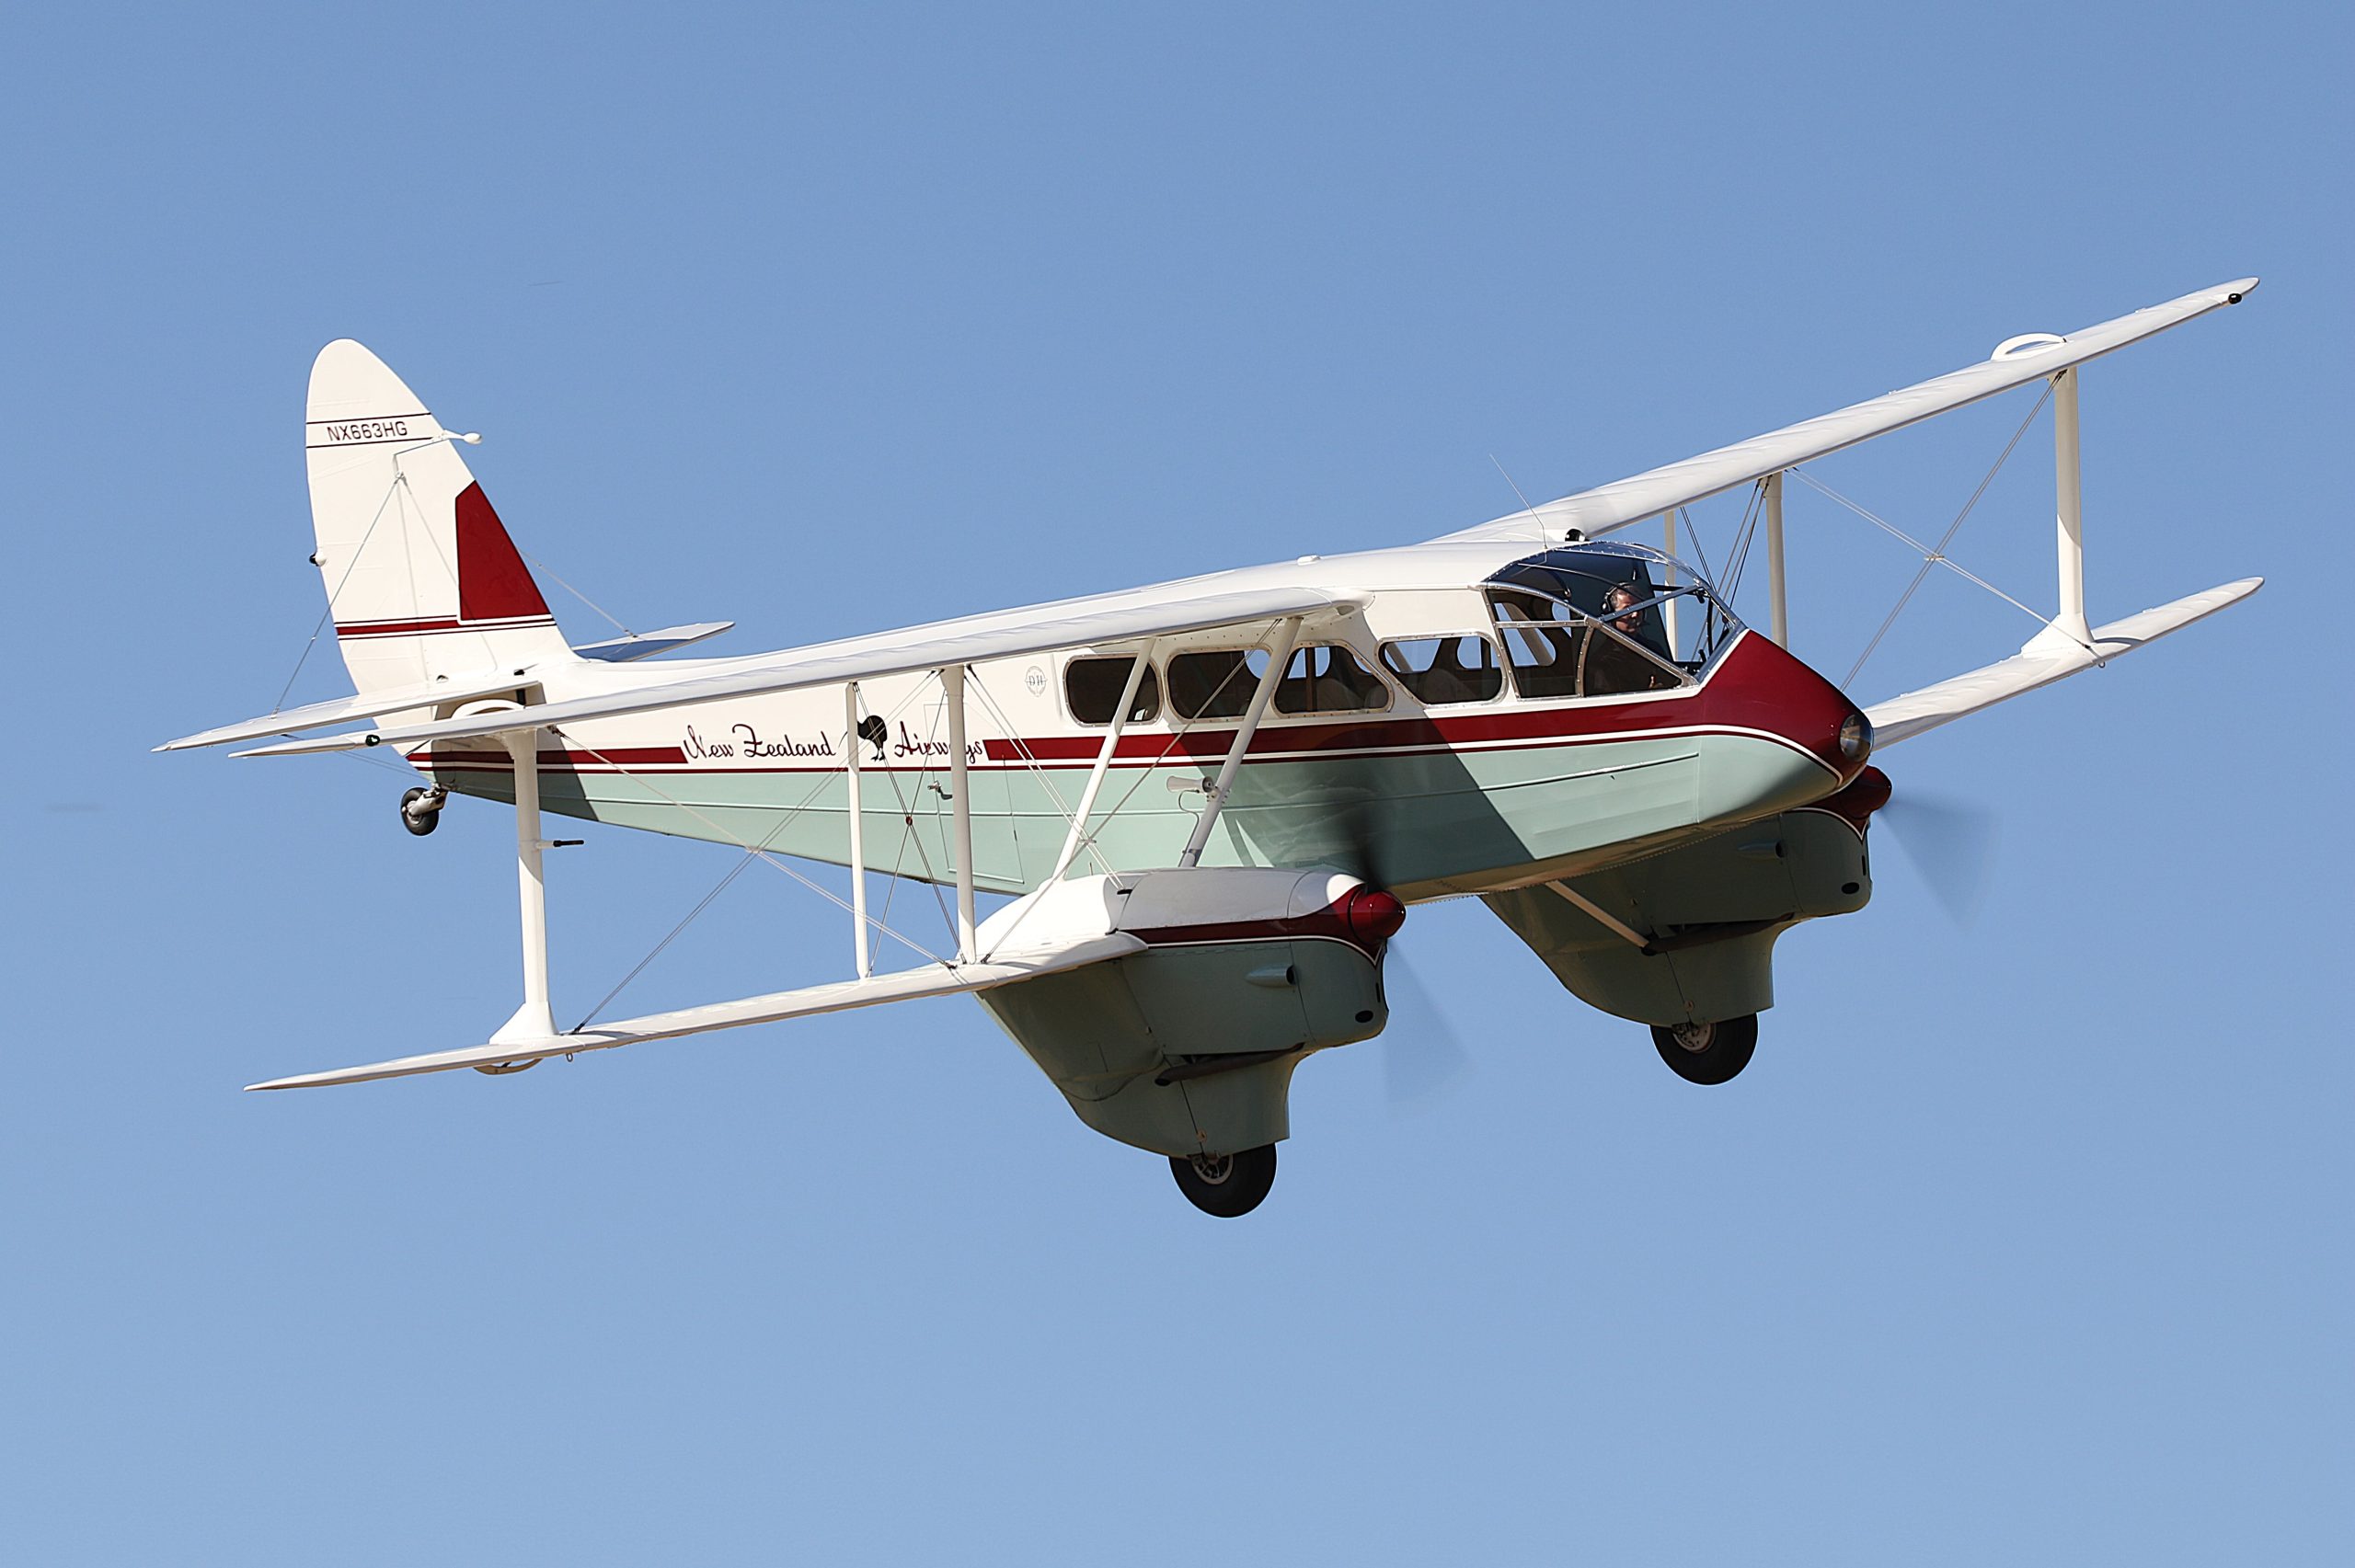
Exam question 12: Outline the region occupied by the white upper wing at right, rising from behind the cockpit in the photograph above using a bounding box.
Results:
[1446,278,2256,539]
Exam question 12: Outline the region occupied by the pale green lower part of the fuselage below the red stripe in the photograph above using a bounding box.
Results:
[436,732,1837,902]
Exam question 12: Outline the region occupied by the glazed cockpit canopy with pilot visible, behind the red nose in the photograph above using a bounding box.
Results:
[1486,539,1740,697]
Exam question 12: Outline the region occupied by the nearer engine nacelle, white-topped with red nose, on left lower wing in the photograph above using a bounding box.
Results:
[980,866,1406,1153]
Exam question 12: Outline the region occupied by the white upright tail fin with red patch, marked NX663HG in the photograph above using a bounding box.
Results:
[304,339,575,697]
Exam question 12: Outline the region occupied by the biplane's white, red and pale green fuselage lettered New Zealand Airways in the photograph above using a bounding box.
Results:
[412,544,1863,902]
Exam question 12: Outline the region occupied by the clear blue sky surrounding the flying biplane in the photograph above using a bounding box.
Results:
[0,5,2355,1563]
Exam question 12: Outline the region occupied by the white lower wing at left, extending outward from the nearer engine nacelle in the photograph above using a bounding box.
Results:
[245,933,1144,1090]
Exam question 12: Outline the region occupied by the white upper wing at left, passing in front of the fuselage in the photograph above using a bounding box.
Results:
[224,589,1366,756]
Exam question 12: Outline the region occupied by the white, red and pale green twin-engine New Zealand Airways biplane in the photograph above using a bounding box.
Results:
[163,278,2261,1215]
